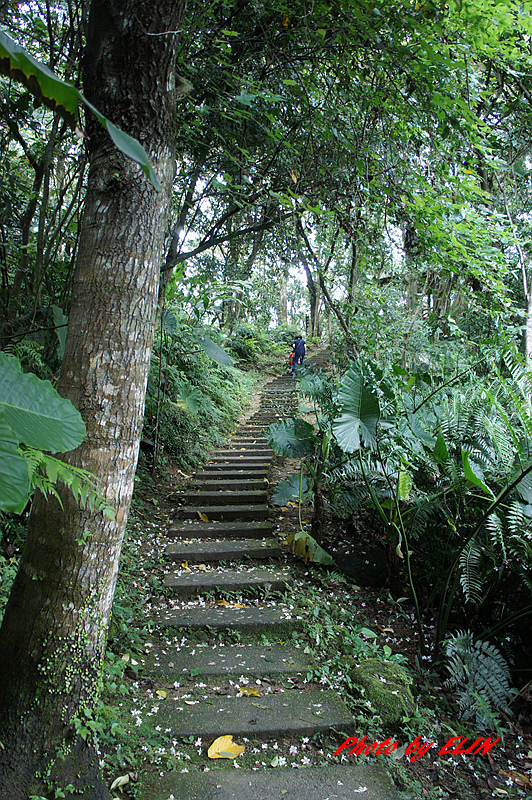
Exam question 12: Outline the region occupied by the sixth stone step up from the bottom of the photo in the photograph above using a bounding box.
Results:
[163,539,283,562]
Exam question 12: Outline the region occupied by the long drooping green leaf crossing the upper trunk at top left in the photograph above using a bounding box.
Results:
[0,31,161,192]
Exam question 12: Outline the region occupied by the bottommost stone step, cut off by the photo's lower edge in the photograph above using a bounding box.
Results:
[138,764,399,800]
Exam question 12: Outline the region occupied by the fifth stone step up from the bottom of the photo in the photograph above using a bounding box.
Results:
[163,567,293,597]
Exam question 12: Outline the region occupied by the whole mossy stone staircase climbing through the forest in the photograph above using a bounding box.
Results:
[139,354,397,800]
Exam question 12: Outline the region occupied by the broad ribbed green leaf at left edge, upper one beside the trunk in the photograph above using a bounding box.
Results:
[0,353,85,453]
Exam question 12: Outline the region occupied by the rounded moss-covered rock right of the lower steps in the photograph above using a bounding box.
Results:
[349,658,416,728]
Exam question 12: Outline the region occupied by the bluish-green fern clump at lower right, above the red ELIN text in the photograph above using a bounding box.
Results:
[444,631,516,731]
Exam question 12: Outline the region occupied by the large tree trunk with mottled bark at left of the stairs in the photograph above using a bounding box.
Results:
[0,0,184,800]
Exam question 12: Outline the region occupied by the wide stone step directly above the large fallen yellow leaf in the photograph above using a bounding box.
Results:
[138,687,354,738]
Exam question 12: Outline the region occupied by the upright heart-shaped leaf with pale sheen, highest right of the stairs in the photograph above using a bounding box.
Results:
[333,367,380,453]
